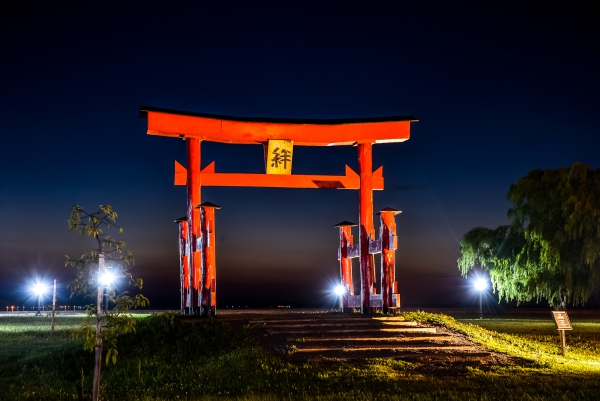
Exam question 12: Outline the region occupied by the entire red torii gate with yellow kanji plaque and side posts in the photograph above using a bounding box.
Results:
[140,106,418,315]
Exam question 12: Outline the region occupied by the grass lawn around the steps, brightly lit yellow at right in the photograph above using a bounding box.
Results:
[0,313,600,401]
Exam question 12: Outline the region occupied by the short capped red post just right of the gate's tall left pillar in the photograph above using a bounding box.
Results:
[197,202,221,316]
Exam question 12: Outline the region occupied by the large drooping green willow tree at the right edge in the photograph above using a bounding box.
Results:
[458,163,600,309]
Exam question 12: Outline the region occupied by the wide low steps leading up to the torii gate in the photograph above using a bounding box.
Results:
[249,314,494,363]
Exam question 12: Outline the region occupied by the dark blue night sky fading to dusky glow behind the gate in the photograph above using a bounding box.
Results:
[0,1,600,309]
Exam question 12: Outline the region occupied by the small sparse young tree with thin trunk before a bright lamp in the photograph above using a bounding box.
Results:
[66,205,149,400]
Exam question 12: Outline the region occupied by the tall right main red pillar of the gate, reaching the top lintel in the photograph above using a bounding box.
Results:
[358,143,375,313]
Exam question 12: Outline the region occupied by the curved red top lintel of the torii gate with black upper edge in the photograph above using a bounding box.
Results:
[140,106,418,146]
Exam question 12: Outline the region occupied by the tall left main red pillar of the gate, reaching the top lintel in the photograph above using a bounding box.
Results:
[186,138,201,313]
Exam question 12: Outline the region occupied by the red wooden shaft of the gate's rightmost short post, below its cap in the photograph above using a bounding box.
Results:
[380,211,397,309]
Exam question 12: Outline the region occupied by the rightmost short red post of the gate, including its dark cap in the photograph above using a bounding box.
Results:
[379,207,402,313]
